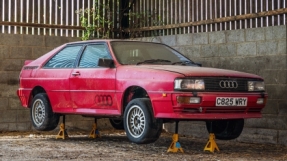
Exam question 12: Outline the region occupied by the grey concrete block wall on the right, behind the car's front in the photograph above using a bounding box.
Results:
[138,26,287,145]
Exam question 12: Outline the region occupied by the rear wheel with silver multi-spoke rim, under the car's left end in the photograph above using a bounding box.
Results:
[30,93,60,131]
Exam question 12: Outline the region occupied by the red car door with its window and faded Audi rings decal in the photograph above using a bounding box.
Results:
[70,43,117,114]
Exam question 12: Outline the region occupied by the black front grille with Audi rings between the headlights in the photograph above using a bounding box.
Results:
[203,77,264,92]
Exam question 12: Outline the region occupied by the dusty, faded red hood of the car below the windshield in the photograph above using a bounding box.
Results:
[137,65,262,79]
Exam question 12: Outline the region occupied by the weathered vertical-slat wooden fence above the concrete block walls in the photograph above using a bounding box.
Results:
[0,0,287,38]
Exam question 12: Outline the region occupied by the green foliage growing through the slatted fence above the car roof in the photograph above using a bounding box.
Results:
[76,0,164,40]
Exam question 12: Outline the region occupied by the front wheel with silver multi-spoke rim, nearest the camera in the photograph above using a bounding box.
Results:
[124,98,162,144]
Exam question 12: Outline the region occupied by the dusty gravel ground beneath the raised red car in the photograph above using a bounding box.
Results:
[0,130,287,161]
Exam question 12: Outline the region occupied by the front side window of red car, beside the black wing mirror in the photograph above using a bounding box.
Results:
[79,44,111,68]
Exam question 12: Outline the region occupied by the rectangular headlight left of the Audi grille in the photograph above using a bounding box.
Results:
[174,79,205,90]
